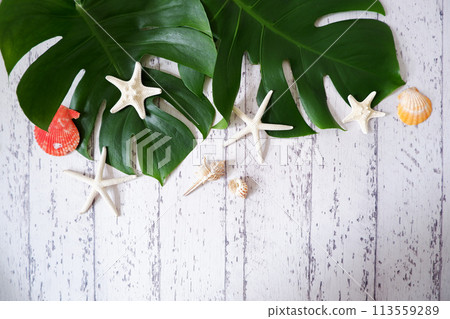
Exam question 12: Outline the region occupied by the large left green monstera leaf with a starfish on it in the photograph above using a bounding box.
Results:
[0,0,217,182]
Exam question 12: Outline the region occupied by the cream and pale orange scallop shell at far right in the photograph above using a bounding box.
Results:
[398,88,433,125]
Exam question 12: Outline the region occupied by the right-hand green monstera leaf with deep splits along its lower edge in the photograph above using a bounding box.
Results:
[202,0,404,137]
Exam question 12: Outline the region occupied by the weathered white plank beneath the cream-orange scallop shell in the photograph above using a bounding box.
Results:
[376,0,443,300]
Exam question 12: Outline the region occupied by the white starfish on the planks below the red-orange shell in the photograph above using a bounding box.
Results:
[64,147,137,216]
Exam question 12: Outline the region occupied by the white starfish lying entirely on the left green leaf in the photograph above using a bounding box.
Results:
[106,62,162,119]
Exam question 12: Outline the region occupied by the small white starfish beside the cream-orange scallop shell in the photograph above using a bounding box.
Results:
[342,92,386,134]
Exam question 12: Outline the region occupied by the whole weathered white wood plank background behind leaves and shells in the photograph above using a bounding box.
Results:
[0,0,450,300]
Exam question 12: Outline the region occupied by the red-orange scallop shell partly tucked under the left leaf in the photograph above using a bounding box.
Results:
[34,105,80,156]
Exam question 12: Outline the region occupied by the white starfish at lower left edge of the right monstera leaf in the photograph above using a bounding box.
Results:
[224,91,293,164]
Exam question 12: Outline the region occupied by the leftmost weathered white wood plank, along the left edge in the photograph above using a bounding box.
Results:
[0,53,32,300]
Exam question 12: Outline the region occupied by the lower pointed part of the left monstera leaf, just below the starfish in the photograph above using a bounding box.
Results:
[100,69,215,183]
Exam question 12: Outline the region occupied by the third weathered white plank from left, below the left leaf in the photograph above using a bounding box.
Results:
[95,59,161,300]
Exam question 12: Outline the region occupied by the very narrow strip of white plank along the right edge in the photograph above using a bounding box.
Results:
[440,0,450,301]
